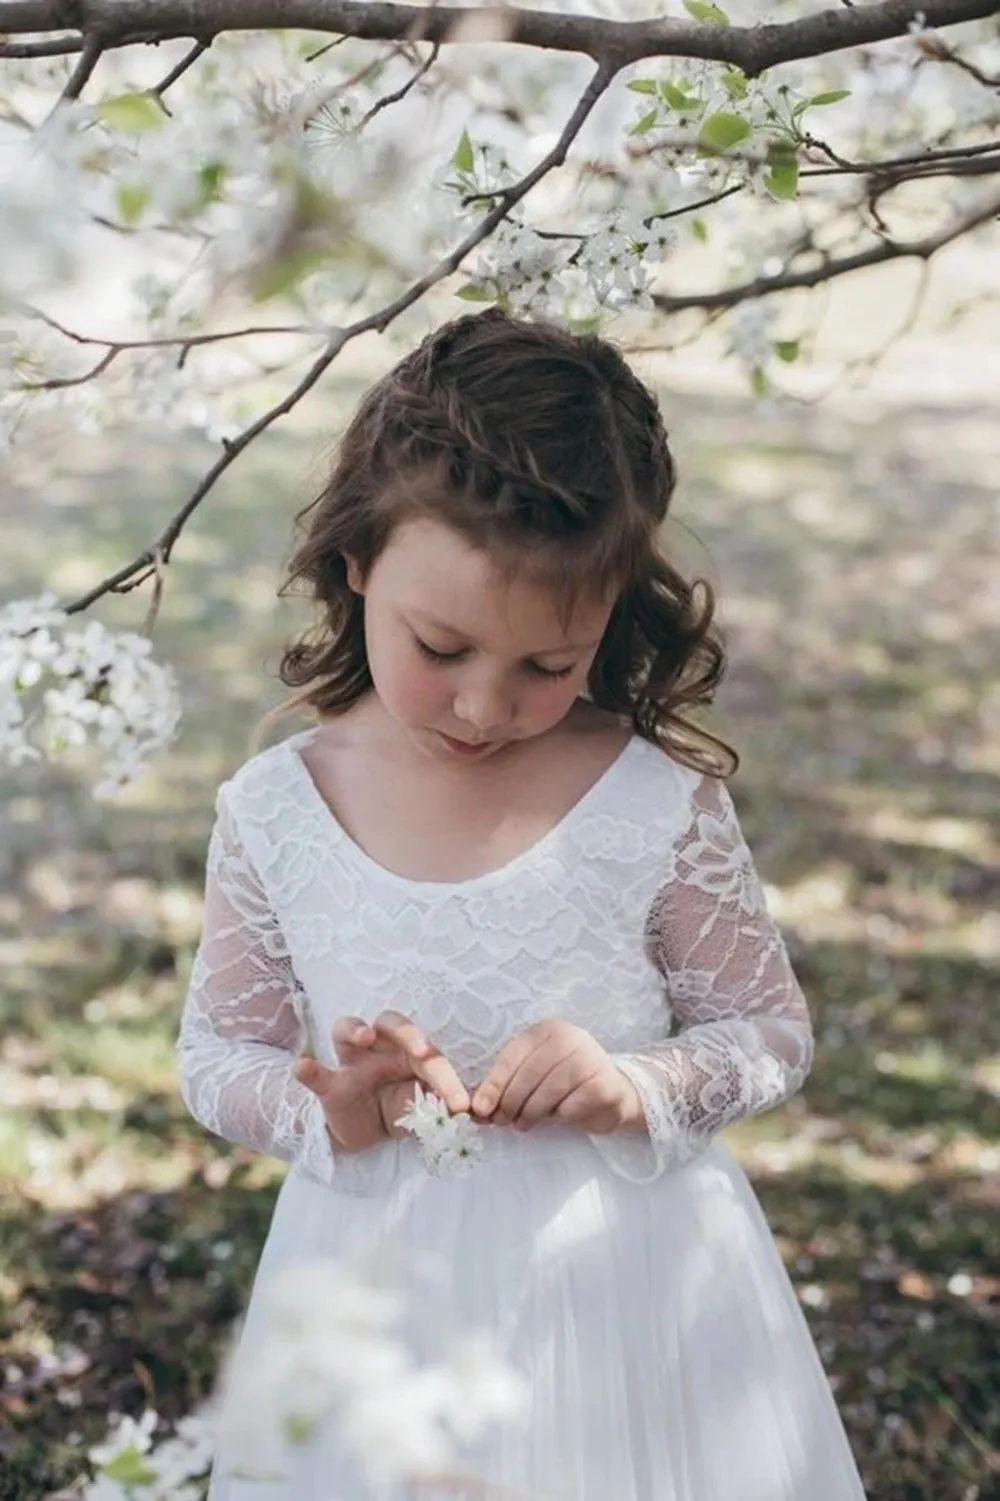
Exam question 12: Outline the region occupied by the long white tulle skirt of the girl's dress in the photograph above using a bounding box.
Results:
[209,1130,865,1501]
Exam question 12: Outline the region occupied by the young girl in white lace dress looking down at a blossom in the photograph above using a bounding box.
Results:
[179,311,863,1501]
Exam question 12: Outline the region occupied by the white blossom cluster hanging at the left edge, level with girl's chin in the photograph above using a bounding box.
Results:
[0,594,180,799]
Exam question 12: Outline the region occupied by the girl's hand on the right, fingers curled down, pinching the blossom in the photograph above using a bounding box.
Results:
[471,1018,646,1135]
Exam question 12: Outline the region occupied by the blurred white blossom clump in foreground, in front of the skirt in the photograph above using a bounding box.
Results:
[210,1256,524,1490]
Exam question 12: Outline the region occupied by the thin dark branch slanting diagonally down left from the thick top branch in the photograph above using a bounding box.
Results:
[66,66,617,615]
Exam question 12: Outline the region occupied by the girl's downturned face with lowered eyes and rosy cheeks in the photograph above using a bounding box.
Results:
[348,518,614,763]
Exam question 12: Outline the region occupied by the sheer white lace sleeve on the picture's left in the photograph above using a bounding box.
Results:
[177,788,335,1183]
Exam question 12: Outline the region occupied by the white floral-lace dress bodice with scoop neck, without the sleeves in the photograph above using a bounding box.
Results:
[225,731,698,1084]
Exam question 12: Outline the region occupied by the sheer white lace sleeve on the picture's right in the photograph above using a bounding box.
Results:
[595,778,812,1181]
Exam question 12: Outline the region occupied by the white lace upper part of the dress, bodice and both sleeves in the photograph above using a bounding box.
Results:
[179,731,811,1192]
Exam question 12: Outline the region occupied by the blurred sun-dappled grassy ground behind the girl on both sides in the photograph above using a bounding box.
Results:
[0,398,1000,1501]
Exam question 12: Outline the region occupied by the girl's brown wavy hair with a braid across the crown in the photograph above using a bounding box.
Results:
[255,309,739,776]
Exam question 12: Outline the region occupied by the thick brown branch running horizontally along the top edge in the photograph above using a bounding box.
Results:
[0,0,997,77]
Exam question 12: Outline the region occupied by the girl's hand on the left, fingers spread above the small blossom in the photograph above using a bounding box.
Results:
[293,1012,468,1151]
